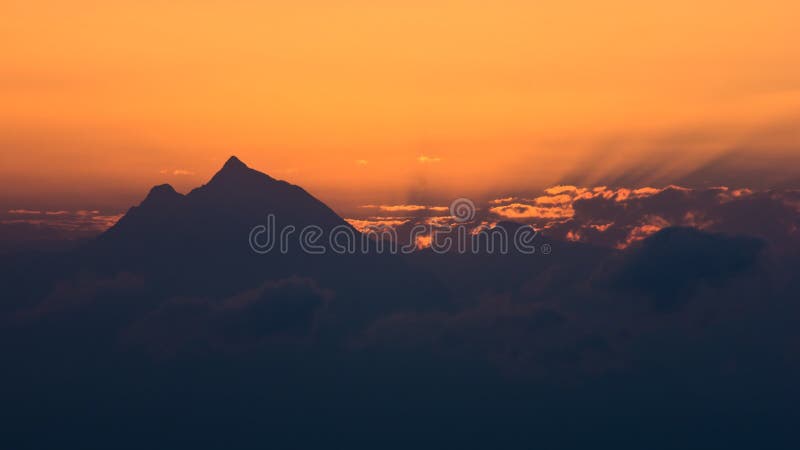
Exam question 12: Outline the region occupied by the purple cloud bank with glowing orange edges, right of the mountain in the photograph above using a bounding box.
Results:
[482,185,800,248]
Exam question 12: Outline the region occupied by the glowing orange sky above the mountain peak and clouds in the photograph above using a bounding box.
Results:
[0,0,800,213]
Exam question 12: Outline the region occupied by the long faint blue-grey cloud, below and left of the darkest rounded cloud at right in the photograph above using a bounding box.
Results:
[360,295,620,379]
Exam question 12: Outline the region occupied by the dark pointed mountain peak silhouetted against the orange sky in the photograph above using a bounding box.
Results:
[98,156,349,249]
